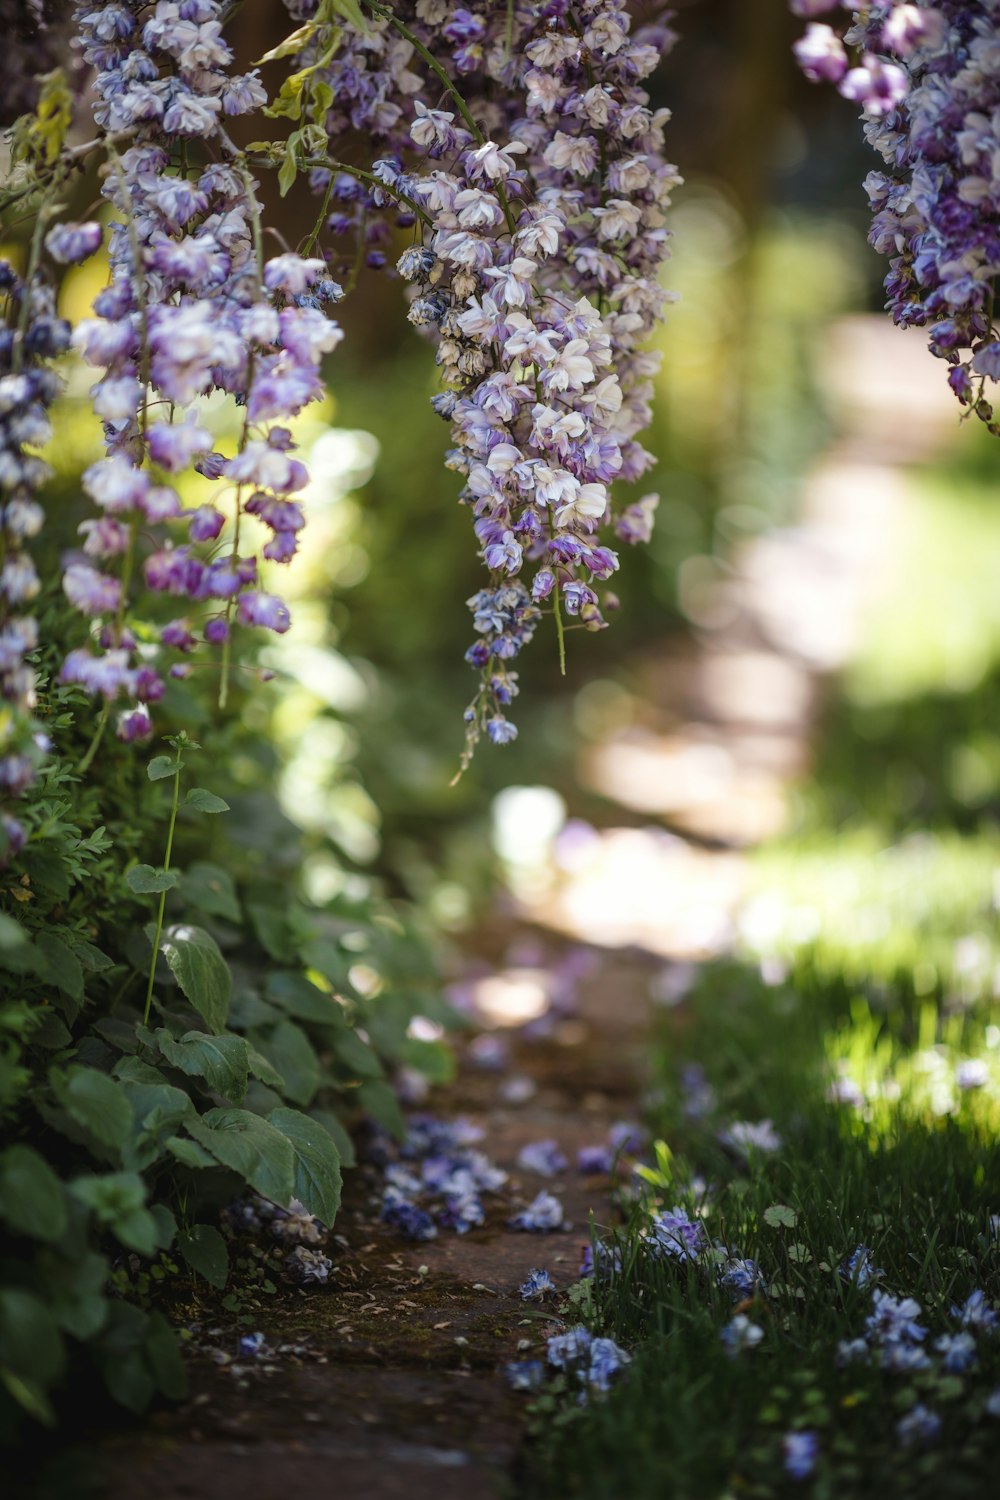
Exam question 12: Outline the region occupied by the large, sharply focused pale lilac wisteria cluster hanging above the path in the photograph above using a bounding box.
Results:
[294,0,679,750]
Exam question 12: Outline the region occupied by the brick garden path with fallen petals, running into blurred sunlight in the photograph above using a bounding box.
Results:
[80,320,955,1500]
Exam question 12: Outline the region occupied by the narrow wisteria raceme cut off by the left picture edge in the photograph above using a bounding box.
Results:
[0,261,69,866]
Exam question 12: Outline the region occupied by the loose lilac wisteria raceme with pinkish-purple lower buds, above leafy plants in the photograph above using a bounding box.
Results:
[63,0,340,740]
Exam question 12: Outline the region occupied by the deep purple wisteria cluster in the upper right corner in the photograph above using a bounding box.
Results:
[792,0,1000,434]
